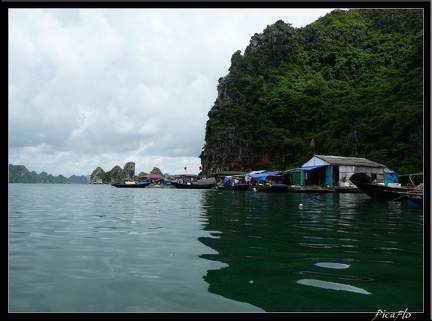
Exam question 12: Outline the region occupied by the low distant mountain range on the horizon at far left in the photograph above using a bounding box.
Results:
[9,164,90,184]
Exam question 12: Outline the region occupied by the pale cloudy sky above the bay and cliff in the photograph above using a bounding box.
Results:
[8,8,332,177]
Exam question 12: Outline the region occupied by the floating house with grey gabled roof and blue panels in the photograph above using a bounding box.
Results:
[298,155,390,187]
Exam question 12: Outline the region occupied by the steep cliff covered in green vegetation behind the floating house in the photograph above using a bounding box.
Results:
[199,9,424,174]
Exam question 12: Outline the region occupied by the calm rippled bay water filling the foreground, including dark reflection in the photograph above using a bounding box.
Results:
[8,184,425,312]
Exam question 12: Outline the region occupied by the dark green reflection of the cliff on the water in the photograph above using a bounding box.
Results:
[199,191,421,312]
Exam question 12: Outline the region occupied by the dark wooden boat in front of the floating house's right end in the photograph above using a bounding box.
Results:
[350,173,423,201]
